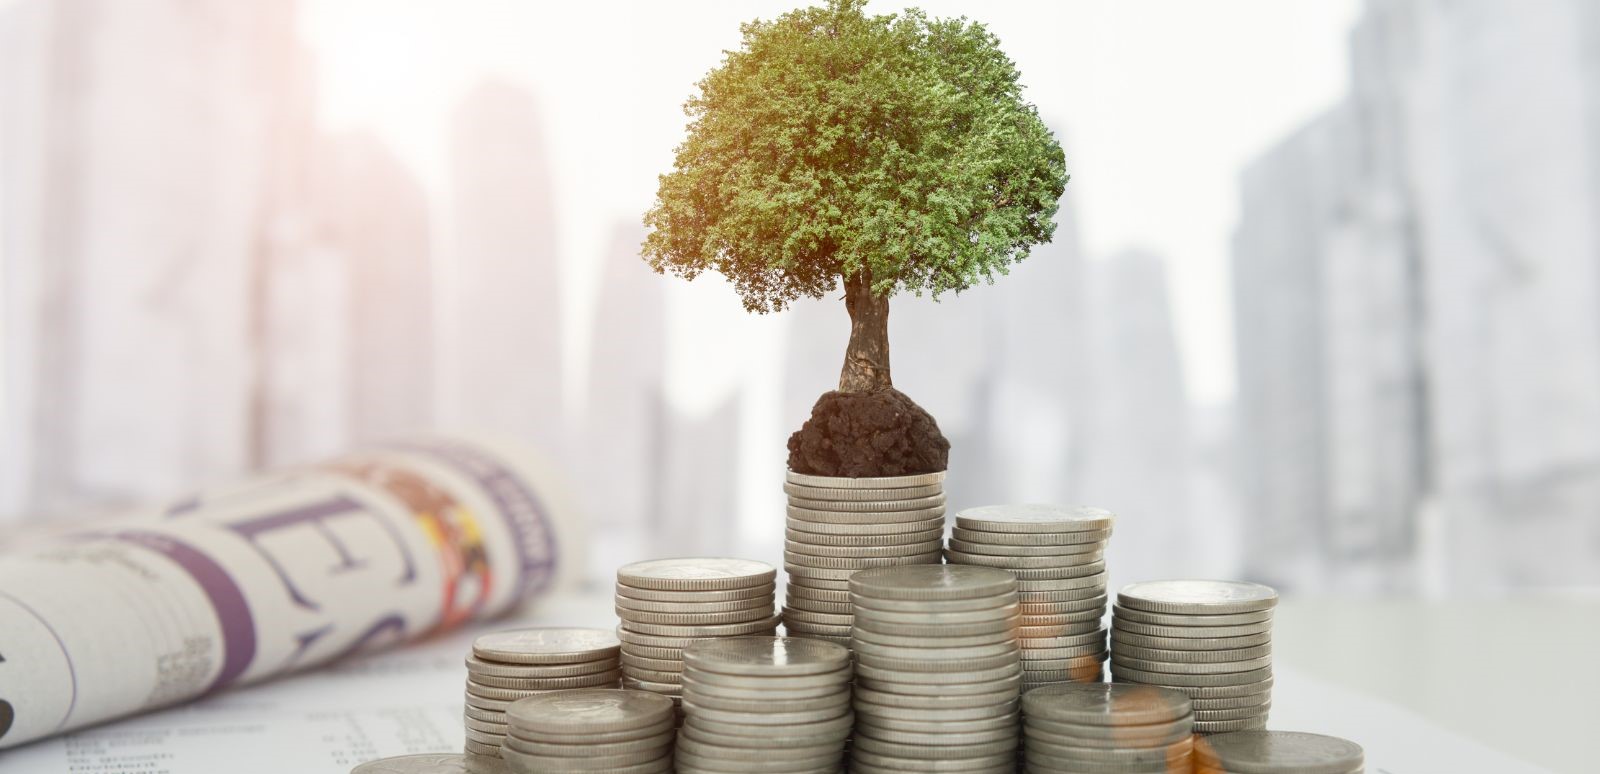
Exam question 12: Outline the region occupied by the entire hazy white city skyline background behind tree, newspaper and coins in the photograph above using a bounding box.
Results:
[0,0,1600,593]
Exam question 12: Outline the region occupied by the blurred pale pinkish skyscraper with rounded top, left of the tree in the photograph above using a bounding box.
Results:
[440,80,565,449]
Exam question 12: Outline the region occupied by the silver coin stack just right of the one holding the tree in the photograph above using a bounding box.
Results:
[946,505,1115,691]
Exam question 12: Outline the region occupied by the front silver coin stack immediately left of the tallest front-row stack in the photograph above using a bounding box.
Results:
[677,636,854,774]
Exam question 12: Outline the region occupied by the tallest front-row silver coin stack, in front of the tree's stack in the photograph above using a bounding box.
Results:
[850,565,1022,774]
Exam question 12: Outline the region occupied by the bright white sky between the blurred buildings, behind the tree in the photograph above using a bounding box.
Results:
[304,0,1360,403]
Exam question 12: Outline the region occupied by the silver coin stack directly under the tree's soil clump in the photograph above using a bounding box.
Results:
[784,472,944,646]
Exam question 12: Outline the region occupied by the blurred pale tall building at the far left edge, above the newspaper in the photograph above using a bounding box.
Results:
[0,0,296,518]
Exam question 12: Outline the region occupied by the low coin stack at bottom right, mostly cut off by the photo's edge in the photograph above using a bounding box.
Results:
[1195,731,1366,774]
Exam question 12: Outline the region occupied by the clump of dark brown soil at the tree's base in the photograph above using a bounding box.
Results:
[789,387,950,478]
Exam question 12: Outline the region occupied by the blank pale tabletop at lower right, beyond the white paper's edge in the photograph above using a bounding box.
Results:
[1272,595,1600,772]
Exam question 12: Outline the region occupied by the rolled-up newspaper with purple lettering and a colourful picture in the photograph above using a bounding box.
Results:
[0,440,582,748]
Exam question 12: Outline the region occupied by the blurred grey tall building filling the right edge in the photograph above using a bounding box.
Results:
[1235,0,1600,588]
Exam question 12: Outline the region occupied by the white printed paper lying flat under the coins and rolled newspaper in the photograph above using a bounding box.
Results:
[0,596,1546,774]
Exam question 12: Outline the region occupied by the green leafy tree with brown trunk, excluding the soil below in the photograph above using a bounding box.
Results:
[643,0,1067,392]
